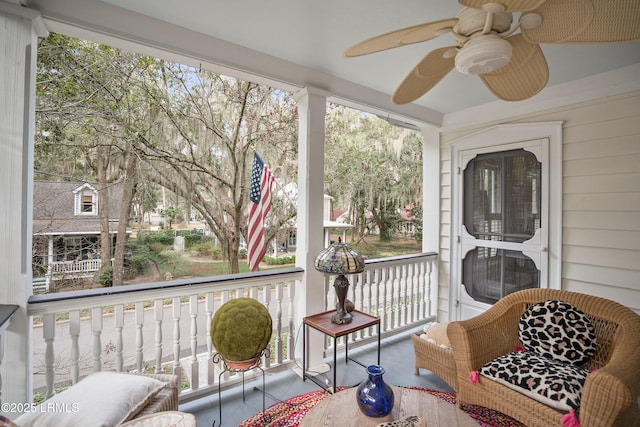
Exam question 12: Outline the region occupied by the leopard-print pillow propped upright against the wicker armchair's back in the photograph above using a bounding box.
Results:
[518,300,596,366]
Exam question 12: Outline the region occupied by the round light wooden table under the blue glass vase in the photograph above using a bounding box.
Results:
[300,387,478,427]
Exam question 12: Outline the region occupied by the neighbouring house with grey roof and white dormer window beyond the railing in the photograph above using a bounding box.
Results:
[32,181,120,291]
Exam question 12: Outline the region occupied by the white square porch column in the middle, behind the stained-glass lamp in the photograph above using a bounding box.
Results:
[295,88,327,372]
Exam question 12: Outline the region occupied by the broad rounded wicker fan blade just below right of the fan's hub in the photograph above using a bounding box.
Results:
[480,34,549,101]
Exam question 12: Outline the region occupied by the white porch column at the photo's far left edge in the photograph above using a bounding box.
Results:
[0,1,46,408]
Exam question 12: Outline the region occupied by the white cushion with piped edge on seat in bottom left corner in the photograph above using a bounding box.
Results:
[15,371,166,427]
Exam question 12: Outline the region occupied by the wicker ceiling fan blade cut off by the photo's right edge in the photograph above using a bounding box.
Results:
[522,0,640,43]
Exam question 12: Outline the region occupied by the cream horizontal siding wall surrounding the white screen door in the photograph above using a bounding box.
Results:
[438,91,640,320]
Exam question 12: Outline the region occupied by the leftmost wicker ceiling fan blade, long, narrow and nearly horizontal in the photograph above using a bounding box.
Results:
[344,18,458,57]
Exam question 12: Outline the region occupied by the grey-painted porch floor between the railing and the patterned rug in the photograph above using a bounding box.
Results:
[179,328,452,427]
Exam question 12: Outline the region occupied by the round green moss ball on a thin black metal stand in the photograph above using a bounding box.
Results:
[211,298,272,361]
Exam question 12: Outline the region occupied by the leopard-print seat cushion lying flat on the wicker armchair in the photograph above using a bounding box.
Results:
[480,351,589,411]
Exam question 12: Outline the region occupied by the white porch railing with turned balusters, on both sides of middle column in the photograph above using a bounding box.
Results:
[28,254,437,402]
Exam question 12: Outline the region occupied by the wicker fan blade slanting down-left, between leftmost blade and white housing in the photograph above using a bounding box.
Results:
[391,46,455,104]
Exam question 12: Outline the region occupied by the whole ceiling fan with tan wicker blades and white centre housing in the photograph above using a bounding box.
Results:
[344,0,640,104]
